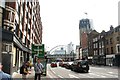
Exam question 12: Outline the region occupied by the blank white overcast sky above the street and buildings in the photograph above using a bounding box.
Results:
[39,0,119,50]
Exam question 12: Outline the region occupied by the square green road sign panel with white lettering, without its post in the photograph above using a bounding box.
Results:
[32,44,44,58]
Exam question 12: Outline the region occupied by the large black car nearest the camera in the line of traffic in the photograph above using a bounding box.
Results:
[71,60,89,73]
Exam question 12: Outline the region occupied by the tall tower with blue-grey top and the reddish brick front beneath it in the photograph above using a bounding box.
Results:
[79,19,93,56]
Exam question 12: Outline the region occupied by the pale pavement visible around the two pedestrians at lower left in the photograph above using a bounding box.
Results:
[12,67,48,80]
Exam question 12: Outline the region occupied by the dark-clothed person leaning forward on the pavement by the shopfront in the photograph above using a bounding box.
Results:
[20,62,30,80]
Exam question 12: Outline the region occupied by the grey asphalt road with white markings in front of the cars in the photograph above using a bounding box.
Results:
[47,64,118,80]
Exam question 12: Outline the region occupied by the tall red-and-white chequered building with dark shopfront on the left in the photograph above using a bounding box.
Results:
[2,0,42,74]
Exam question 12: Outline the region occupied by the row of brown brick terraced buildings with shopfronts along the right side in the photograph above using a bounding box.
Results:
[88,26,120,66]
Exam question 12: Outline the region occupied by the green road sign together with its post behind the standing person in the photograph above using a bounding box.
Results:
[32,44,47,76]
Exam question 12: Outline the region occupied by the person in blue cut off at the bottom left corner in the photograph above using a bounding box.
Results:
[0,62,12,80]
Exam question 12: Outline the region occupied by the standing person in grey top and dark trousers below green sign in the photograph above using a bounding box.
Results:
[34,58,44,80]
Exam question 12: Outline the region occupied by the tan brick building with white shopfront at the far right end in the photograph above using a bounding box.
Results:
[105,26,120,66]
